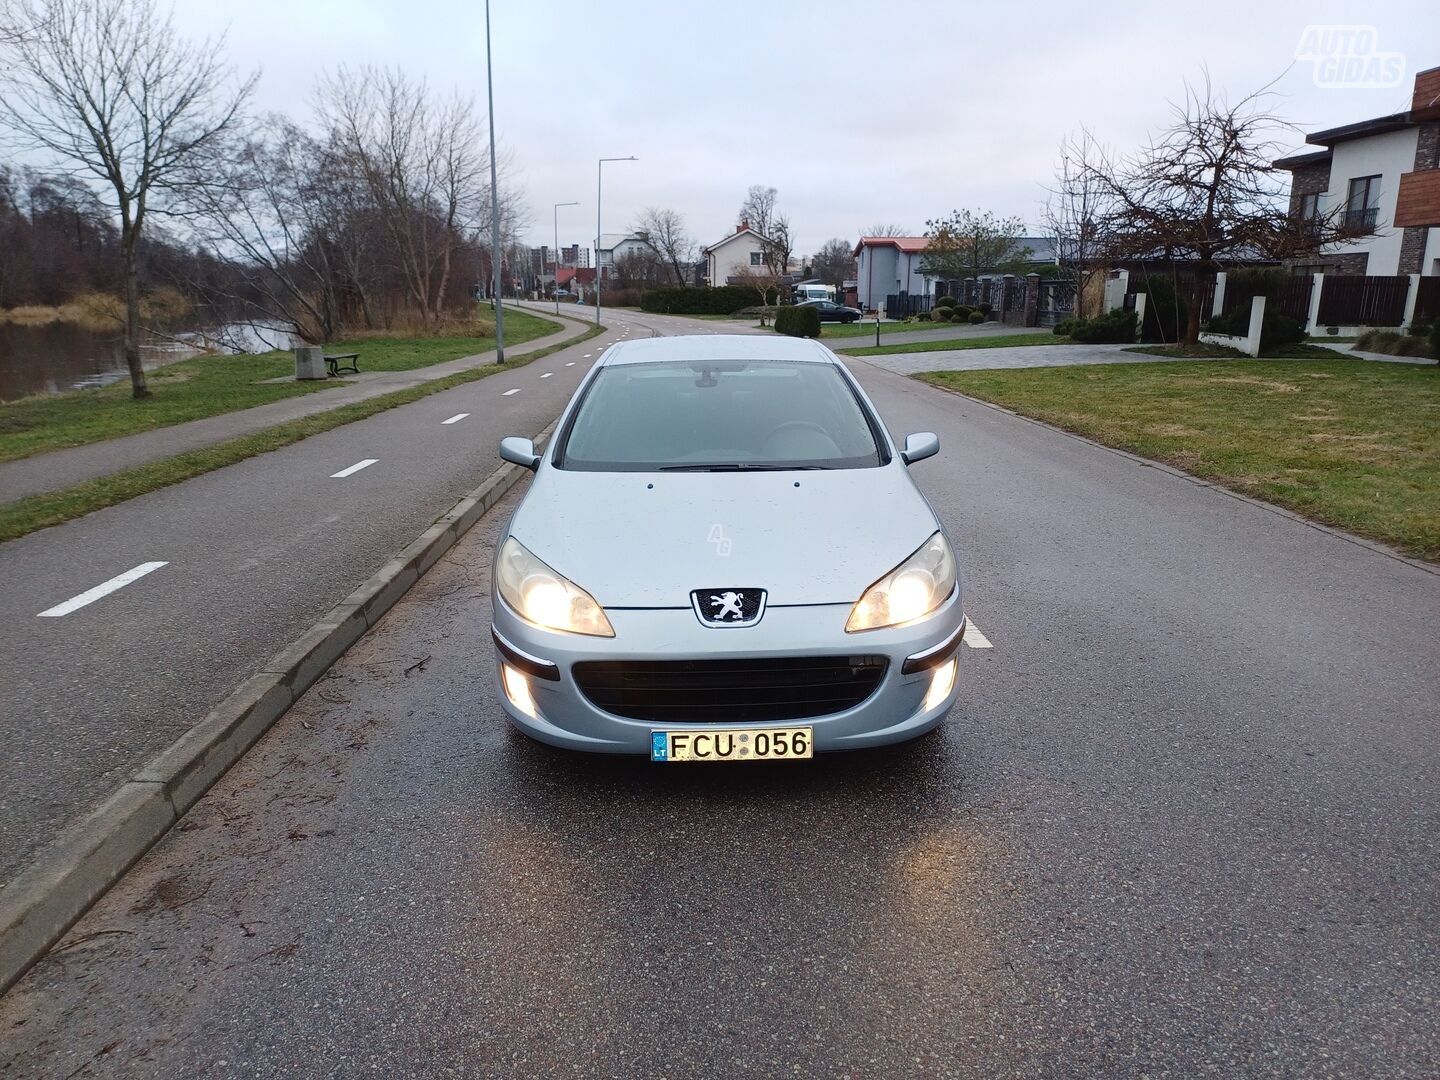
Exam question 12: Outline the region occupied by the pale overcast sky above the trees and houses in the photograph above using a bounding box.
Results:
[176,0,1440,252]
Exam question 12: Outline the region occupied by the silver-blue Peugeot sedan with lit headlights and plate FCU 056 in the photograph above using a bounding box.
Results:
[492,334,965,762]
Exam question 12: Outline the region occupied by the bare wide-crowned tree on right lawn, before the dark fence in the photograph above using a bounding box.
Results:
[1086,78,1374,344]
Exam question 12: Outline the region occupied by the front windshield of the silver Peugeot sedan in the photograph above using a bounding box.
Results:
[556,360,884,472]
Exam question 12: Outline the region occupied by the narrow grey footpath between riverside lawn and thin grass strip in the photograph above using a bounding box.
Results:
[0,312,589,503]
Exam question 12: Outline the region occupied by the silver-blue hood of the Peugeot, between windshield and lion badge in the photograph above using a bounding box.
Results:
[510,462,939,608]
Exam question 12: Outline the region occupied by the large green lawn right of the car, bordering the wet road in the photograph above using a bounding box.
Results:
[916,360,1440,560]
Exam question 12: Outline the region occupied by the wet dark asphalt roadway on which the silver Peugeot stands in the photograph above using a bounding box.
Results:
[0,308,1440,1077]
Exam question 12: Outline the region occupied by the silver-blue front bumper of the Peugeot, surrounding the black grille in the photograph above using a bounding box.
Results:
[494,588,965,755]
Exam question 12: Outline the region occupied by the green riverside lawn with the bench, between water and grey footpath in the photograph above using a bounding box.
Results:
[0,308,560,461]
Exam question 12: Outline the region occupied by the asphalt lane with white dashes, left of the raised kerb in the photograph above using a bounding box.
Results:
[0,318,649,886]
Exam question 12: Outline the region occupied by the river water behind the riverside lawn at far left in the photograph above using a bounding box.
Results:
[0,323,294,402]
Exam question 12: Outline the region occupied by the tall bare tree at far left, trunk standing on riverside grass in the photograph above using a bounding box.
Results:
[0,0,255,397]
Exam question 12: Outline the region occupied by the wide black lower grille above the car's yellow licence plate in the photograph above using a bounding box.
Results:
[572,655,887,724]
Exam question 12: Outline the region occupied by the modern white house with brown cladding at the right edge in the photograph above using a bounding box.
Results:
[1274,68,1440,276]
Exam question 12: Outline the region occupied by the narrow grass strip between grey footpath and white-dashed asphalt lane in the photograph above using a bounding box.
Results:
[0,319,605,543]
